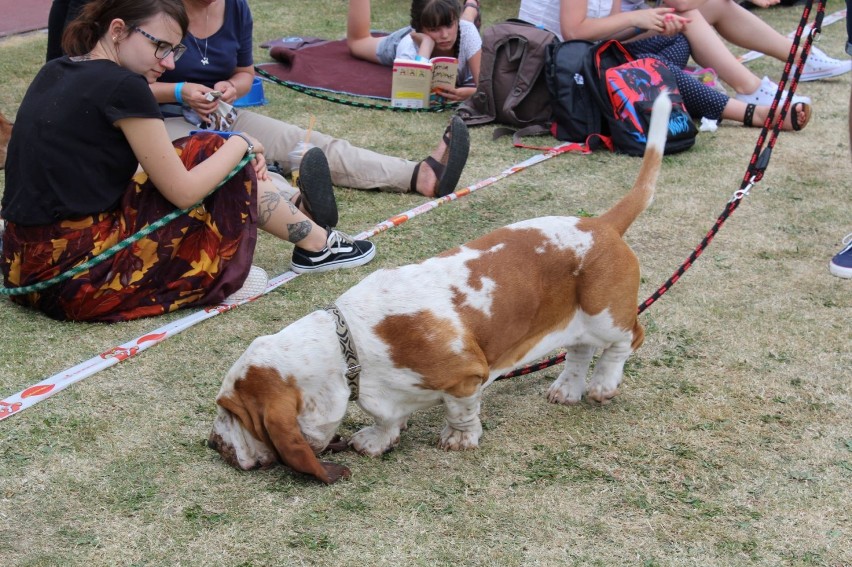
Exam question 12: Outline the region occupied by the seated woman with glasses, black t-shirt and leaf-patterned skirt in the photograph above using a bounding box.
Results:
[0,0,375,322]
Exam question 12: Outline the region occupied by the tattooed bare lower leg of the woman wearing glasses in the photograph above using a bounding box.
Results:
[257,176,328,252]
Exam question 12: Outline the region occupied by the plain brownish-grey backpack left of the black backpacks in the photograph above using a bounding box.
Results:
[458,19,559,130]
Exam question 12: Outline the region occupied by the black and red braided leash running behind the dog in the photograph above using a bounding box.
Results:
[495,0,824,381]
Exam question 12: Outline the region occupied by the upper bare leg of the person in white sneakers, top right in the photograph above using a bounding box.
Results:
[698,0,793,62]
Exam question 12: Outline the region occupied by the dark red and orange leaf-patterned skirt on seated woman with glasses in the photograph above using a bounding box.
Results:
[0,130,257,322]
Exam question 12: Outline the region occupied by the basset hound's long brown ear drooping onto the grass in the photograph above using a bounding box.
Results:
[225,366,351,484]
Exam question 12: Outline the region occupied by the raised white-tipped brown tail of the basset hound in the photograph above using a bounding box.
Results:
[600,91,672,235]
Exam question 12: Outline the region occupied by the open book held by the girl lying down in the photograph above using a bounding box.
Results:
[391,57,459,108]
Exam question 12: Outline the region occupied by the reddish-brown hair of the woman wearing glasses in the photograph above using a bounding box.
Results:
[62,0,189,56]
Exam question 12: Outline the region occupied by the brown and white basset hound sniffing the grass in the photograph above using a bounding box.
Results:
[209,92,671,483]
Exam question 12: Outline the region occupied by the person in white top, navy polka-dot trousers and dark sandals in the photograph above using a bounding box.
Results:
[519,0,811,130]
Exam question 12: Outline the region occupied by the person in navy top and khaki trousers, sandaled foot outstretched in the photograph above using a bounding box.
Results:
[151,0,469,203]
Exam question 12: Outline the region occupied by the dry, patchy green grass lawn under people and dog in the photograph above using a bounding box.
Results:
[0,0,852,567]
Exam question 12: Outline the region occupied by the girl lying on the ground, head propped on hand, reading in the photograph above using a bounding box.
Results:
[346,0,482,102]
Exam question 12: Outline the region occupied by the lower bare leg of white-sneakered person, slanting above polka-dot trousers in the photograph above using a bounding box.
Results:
[683,7,760,94]
